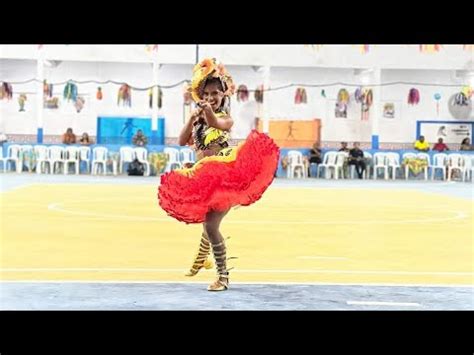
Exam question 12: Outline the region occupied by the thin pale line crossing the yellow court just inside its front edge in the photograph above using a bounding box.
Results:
[0,268,474,276]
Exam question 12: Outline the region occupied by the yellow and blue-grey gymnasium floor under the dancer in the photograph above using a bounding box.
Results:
[0,173,474,310]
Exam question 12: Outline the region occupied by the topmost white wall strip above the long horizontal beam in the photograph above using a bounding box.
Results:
[0,44,474,70]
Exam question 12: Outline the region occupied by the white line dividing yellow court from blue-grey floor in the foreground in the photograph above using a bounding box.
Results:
[0,280,474,289]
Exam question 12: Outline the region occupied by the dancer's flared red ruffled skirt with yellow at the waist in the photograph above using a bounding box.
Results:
[158,130,280,223]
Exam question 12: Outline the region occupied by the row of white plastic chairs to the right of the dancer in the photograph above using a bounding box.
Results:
[287,150,474,181]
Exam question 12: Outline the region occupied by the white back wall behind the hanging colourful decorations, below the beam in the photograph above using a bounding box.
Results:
[0,59,474,143]
